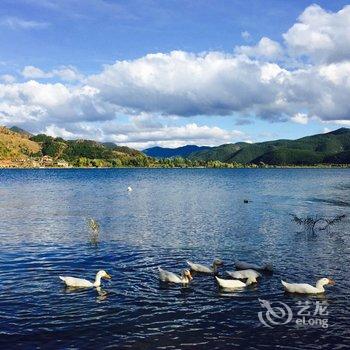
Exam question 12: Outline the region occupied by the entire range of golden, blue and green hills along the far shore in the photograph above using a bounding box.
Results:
[0,126,350,167]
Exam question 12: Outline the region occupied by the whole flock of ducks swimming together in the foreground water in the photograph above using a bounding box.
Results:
[59,259,335,294]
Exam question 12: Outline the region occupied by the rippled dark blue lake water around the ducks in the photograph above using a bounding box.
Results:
[0,169,350,349]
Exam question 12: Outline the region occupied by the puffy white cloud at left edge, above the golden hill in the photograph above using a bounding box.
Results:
[0,80,116,125]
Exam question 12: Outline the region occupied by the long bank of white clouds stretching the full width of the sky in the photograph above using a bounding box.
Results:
[0,45,350,142]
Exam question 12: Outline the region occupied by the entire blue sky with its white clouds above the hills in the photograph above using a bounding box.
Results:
[0,0,350,148]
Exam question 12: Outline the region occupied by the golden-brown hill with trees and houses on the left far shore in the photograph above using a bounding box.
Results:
[0,127,149,167]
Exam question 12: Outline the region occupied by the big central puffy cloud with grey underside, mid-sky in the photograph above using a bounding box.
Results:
[87,51,284,116]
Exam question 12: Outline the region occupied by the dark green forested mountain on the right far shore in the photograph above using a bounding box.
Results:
[189,128,350,165]
